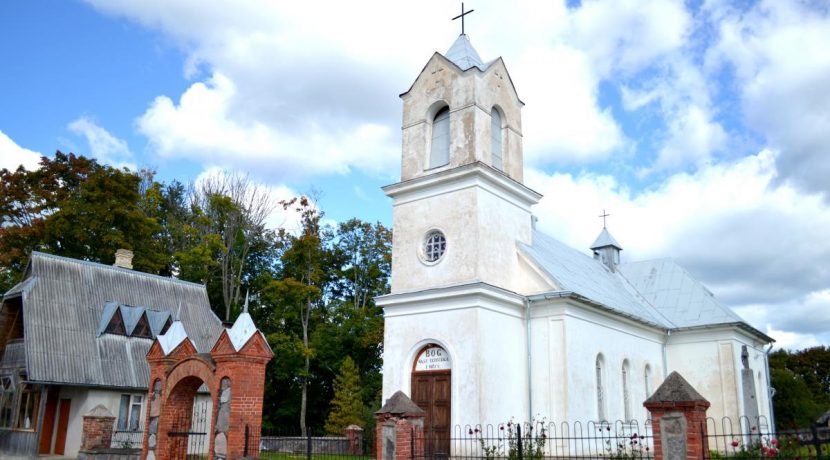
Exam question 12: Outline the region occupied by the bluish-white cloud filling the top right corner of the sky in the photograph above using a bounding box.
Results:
[707,0,830,194]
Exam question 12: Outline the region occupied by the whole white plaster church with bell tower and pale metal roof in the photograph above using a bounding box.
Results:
[377,33,773,454]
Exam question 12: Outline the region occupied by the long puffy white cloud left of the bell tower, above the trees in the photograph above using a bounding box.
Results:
[138,74,398,179]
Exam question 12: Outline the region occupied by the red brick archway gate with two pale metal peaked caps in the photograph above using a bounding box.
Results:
[142,308,273,460]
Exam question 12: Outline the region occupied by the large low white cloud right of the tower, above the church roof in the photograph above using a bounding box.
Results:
[525,151,830,343]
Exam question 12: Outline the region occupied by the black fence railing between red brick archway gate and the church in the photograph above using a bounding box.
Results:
[254,426,375,460]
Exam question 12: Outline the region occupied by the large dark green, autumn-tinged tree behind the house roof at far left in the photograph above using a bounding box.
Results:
[0,151,166,291]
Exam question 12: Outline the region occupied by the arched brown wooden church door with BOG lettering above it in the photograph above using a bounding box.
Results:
[412,345,452,458]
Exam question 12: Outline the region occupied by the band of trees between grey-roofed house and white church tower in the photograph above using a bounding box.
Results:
[0,152,392,433]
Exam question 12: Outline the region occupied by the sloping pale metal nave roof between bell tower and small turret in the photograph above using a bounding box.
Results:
[519,230,673,328]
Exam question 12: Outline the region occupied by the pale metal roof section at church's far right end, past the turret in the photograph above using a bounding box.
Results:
[619,259,744,327]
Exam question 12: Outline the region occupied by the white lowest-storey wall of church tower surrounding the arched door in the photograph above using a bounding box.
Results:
[383,298,527,426]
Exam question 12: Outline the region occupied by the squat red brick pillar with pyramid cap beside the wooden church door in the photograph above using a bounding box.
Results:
[375,391,425,460]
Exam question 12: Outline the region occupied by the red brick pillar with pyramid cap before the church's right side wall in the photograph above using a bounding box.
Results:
[643,372,709,460]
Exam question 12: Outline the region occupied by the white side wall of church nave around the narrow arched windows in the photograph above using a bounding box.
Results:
[531,303,663,423]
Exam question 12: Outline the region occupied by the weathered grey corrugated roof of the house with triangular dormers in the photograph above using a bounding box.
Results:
[16,252,222,388]
